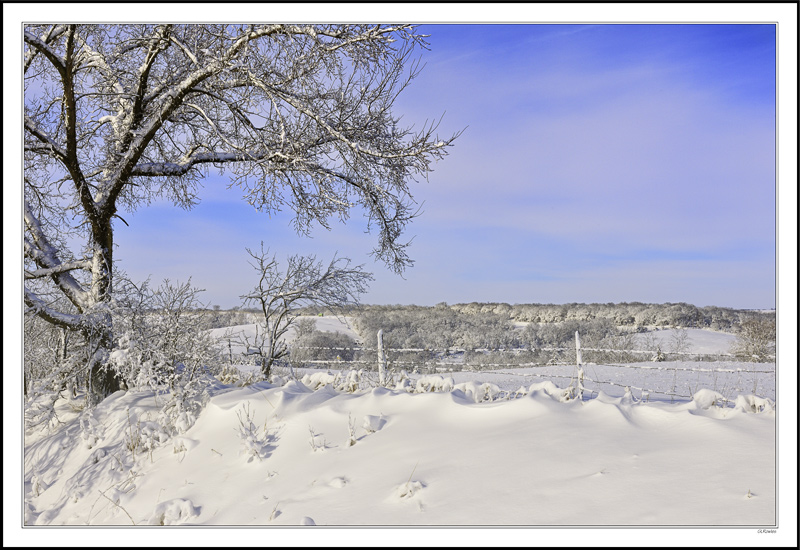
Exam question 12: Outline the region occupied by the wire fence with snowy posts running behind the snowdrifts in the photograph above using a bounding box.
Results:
[225,336,776,402]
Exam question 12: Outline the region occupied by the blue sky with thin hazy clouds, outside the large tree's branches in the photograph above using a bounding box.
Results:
[106,24,776,308]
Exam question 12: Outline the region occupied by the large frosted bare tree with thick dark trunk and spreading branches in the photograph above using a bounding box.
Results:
[24,24,457,406]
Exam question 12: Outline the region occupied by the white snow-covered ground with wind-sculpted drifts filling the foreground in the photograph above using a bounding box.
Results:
[23,320,780,543]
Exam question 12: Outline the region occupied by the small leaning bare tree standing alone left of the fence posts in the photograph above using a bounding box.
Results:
[241,246,373,377]
